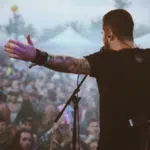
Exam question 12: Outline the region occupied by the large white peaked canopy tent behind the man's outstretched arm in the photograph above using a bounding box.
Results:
[40,27,99,56]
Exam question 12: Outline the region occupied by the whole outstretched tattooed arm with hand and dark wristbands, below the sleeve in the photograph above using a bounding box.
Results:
[5,39,91,74]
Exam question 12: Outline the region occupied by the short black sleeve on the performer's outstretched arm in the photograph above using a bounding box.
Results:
[84,51,102,77]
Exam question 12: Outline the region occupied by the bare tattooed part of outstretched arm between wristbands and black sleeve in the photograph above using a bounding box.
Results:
[45,55,90,74]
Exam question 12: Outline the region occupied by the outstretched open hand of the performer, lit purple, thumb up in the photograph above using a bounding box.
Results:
[4,35,36,61]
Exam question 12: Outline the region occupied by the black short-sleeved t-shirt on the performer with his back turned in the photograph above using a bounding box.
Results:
[85,48,150,150]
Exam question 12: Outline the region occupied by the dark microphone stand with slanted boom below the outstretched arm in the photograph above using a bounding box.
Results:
[54,75,88,150]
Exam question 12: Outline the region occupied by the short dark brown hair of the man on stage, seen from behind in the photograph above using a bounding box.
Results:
[103,9,134,40]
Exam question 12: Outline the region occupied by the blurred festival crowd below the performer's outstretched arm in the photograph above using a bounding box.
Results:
[0,60,100,150]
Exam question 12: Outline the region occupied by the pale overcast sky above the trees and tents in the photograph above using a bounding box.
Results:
[0,0,150,28]
